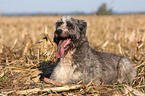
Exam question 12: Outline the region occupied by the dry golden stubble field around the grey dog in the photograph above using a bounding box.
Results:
[0,14,145,95]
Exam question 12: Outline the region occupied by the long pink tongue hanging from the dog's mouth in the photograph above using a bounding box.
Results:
[56,39,70,58]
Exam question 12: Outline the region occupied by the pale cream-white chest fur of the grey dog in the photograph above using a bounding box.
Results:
[53,51,81,84]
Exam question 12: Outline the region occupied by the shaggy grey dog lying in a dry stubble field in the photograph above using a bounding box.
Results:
[50,17,136,84]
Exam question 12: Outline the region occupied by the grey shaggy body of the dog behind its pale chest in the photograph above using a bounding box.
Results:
[68,44,136,84]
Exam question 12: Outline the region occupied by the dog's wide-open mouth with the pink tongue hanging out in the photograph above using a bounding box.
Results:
[56,38,72,58]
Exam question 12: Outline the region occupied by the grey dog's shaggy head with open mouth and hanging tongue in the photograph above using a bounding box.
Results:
[54,16,87,58]
